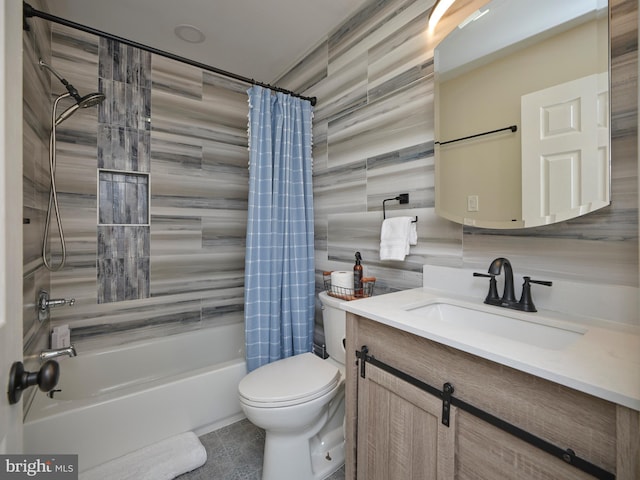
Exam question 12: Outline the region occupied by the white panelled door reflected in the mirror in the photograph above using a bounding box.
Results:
[521,72,609,227]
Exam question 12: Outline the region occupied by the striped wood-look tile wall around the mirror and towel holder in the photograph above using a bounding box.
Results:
[278,0,638,318]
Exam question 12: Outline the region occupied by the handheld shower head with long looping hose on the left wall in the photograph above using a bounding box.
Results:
[38,59,105,271]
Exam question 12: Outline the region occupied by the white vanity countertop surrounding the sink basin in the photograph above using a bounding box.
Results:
[341,288,640,411]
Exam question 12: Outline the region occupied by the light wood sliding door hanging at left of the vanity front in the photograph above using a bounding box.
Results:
[357,364,457,480]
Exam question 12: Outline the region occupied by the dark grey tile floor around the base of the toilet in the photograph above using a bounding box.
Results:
[177,419,344,480]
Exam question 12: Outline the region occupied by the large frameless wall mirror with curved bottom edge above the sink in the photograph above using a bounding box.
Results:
[434,0,610,228]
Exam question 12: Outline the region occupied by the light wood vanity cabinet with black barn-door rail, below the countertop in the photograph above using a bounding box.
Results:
[346,313,640,480]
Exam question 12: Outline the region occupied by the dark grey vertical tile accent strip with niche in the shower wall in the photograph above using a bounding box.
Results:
[96,38,151,303]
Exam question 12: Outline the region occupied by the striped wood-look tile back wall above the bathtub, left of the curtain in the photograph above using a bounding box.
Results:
[38,25,248,350]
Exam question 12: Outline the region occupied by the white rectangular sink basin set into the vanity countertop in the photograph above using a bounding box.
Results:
[406,301,587,350]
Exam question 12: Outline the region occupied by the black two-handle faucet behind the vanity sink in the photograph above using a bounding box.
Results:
[473,257,552,312]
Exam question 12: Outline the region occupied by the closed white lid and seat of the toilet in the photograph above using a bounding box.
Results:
[238,353,340,406]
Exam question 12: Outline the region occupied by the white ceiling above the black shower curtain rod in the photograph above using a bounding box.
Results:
[41,0,368,83]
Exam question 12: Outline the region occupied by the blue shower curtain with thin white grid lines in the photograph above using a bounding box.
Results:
[244,86,315,371]
